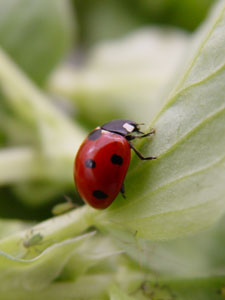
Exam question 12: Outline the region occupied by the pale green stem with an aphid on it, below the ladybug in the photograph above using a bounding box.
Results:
[0,206,96,258]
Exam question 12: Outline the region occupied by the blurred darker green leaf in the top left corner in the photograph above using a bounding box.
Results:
[0,0,73,84]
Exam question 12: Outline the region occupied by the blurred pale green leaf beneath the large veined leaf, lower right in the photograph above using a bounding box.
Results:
[110,212,225,279]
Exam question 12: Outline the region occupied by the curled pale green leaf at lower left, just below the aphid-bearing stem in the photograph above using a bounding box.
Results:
[0,234,90,290]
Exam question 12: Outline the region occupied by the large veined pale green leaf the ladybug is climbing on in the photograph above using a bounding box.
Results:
[98,1,225,240]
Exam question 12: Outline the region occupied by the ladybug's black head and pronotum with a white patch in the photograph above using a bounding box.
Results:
[101,120,142,136]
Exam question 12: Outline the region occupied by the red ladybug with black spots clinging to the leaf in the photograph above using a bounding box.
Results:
[74,120,156,209]
